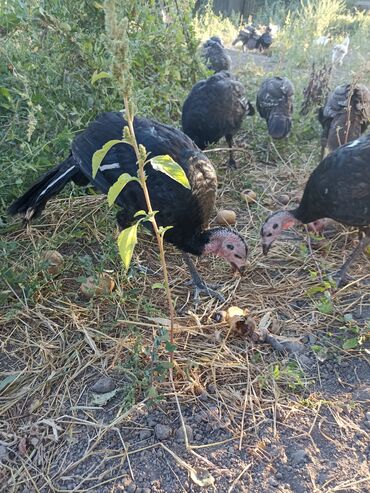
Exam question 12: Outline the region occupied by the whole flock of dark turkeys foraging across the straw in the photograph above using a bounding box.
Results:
[9,29,370,300]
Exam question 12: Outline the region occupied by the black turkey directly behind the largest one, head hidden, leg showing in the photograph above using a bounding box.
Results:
[182,71,254,167]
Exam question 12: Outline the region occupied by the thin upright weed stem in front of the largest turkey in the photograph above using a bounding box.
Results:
[123,96,175,350]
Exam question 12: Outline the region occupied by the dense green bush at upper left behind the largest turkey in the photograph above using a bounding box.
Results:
[0,0,205,214]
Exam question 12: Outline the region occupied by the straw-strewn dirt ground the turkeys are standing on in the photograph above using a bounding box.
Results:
[0,45,370,493]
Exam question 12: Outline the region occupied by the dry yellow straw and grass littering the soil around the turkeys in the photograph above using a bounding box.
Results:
[0,131,370,492]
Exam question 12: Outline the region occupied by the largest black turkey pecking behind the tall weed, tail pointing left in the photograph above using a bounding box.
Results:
[9,112,247,297]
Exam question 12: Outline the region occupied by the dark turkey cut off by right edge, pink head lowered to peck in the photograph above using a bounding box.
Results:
[261,135,370,285]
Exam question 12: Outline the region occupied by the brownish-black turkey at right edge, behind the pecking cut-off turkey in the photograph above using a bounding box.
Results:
[319,84,370,157]
